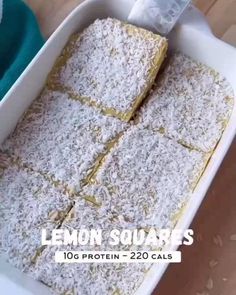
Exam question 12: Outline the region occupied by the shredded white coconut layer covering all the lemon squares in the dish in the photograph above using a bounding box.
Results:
[0,19,233,295]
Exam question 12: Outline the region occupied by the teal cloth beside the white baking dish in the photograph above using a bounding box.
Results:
[0,0,44,100]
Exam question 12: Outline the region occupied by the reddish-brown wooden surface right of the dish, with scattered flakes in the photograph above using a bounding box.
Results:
[154,140,236,295]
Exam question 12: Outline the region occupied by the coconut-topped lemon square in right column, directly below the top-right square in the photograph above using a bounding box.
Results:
[89,125,208,228]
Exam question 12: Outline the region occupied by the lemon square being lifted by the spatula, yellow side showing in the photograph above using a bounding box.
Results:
[49,18,167,121]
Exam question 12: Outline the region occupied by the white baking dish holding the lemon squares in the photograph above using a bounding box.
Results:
[0,0,236,295]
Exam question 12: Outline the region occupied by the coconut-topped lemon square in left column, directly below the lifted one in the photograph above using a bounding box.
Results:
[2,89,126,191]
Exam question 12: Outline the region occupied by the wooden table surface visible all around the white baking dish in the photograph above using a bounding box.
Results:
[24,0,236,295]
